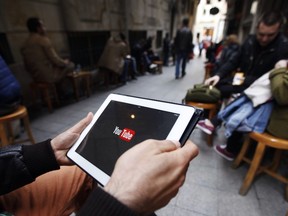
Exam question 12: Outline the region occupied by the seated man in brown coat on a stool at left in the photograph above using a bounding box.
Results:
[21,17,74,83]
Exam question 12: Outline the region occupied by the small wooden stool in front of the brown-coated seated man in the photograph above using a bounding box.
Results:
[67,71,92,101]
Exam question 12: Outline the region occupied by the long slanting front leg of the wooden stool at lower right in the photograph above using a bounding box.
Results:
[239,142,265,195]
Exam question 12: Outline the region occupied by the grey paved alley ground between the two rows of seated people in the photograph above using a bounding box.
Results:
[31,57,288,216]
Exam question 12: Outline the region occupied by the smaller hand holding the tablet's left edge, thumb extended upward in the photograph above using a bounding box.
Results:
[51,112,93,165]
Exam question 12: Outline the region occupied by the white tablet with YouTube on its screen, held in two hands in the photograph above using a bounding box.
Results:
[67,94,202,186]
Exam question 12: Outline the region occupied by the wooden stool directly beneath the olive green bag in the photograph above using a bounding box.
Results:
[186,101,219,147]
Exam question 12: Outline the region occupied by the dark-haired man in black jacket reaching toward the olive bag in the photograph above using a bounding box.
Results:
[205,11,288,98]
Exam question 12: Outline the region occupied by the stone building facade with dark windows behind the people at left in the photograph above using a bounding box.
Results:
[0,0,197,67]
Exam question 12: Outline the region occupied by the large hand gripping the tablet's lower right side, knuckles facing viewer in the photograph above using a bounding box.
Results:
[104,140,198,214]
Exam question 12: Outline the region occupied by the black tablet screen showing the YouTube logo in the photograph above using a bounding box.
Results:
[76,101,179,176]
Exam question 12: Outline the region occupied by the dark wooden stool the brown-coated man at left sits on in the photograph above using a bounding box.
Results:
[30,82,60,112]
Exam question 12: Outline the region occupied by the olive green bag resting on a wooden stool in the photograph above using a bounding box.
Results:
[185,84,221,103]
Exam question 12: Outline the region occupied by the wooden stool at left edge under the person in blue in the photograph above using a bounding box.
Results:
[0,105,35,147]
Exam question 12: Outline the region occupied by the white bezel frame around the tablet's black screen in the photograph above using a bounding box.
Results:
[67,93,196,186]
